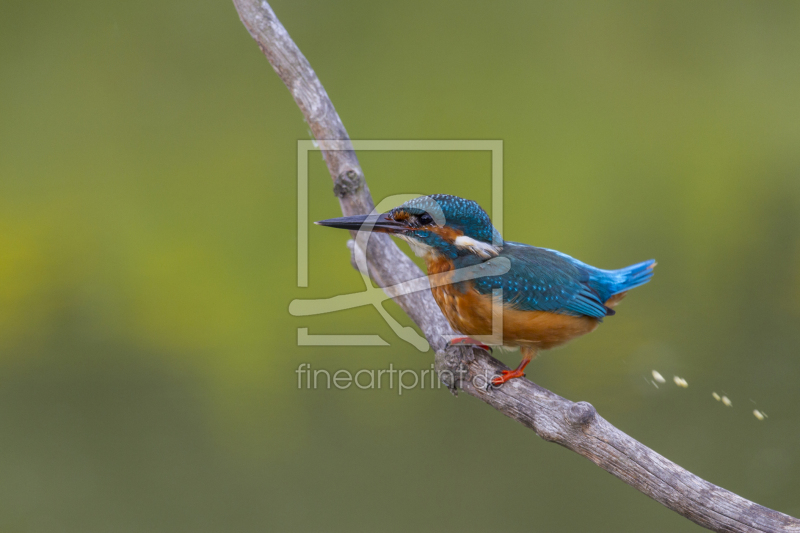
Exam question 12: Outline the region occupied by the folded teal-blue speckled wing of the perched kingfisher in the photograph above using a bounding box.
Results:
[466,241,613,318]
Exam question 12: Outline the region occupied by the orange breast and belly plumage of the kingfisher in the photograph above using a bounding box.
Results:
[427,255,599,350]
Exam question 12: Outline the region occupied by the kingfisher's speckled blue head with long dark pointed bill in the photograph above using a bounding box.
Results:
[317,194,503,259]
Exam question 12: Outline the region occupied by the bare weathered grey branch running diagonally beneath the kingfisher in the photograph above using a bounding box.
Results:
[233,0,800,533]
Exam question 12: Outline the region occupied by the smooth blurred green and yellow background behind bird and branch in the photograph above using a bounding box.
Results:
[0,0,800,533]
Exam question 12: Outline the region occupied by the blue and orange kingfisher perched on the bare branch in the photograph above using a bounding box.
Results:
[317,194,656,386]
